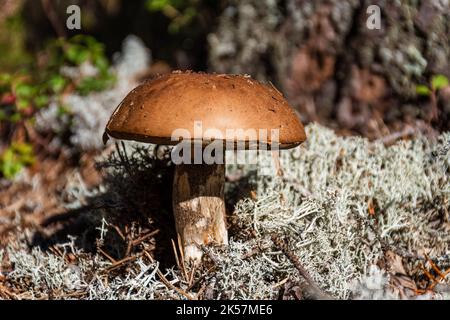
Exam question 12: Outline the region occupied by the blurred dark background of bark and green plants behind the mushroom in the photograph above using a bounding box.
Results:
[0,0,450,179]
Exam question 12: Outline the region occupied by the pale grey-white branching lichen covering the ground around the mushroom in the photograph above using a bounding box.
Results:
[0,124,450,299]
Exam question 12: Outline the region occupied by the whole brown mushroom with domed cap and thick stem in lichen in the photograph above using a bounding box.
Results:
[105,72,306,260]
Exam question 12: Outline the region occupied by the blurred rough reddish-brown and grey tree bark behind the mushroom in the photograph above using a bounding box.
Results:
[208,0,450,134]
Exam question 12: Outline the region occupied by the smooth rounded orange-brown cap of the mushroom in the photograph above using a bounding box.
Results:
[104,71,306,149]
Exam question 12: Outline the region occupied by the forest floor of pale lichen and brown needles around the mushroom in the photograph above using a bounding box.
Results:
[0,124,450,299]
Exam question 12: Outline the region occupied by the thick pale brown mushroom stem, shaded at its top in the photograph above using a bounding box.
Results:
[172,164,228,261]
